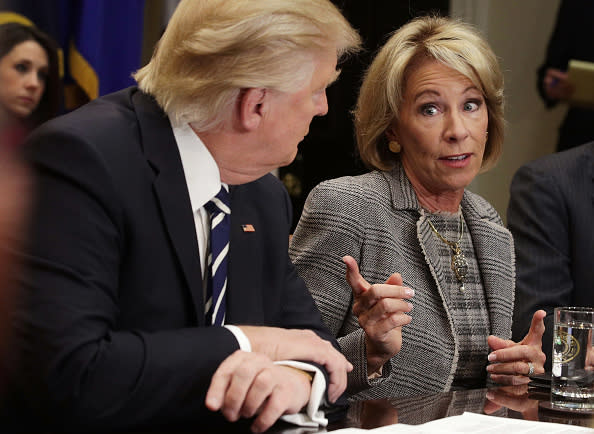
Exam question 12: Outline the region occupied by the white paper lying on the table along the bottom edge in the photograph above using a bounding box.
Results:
[332,412,594,434]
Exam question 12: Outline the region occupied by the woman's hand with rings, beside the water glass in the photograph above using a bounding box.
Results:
[487,310,546,385]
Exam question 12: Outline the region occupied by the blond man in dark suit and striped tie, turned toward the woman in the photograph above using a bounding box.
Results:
[18,0,359,431]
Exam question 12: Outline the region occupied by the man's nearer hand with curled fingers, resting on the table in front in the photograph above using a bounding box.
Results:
[206,350,311,432]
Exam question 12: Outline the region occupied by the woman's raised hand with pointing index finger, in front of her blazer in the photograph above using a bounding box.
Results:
[342,256,414,373]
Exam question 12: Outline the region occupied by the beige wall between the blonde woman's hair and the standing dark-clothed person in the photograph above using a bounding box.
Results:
[451,0,566,220]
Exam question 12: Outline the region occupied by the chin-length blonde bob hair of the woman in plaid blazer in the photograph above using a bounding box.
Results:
[354,16,504,171]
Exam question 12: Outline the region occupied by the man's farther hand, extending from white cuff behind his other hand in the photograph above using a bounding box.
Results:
[239,326,353,402]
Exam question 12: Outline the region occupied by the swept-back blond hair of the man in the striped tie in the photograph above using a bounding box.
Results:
[134,0,360,130]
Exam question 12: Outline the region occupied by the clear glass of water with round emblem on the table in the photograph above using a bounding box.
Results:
[551,307,594,410]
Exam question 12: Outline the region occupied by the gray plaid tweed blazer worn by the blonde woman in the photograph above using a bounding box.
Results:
[290,165,515,398]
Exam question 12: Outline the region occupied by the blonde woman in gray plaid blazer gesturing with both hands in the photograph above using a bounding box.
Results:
[290,17,545,398]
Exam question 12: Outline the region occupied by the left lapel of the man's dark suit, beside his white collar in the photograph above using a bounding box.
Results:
[132,91,204,325]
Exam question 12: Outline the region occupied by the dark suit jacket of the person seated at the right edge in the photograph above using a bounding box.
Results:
[507,142,594,369]
